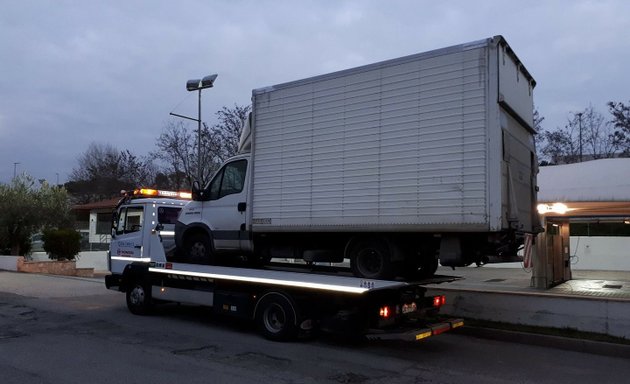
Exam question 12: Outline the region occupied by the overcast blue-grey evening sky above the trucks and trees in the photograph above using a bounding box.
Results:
[0,0,630,183]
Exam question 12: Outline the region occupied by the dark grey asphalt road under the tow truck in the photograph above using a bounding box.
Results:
[0,271,630,384]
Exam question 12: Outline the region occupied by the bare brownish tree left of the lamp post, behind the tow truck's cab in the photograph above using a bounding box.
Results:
[66,143,157,203]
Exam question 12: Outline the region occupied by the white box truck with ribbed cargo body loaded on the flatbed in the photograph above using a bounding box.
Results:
[176,36,539,278]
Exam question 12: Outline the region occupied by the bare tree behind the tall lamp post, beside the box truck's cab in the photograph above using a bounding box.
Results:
[152,104,251,189]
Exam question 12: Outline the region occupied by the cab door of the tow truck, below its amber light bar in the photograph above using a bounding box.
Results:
[109,205,149,273]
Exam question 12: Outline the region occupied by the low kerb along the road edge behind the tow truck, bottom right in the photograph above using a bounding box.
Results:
[457,326,630,359]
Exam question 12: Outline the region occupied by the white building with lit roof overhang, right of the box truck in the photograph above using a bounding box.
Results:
[538,158,630,271]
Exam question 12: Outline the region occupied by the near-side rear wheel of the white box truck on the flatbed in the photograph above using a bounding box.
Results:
[350,240,394,279]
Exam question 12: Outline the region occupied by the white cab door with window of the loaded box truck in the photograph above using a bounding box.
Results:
[202,159,248,251]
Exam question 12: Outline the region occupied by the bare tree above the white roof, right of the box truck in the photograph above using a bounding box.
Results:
[538,105,622,164]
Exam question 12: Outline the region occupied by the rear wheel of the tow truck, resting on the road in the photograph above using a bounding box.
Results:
[256,292,298,341]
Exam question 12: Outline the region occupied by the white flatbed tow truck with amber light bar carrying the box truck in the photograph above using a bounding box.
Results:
[105,190,464,341]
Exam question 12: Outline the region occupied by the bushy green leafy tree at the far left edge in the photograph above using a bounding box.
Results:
[0,174,72,256]
